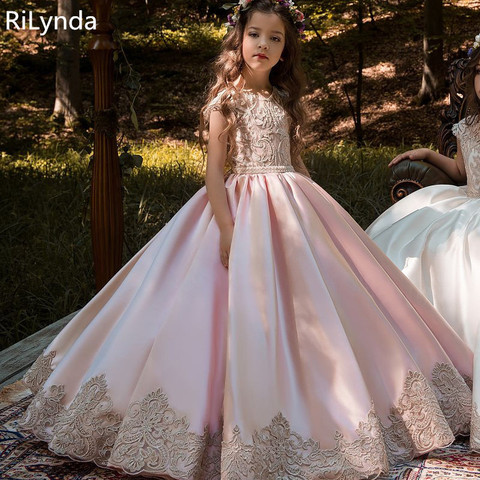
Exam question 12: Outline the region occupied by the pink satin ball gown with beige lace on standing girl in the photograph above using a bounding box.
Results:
[19,90,472,480]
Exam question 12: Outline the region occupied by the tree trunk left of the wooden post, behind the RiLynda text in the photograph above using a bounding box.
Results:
[53,0,80,125]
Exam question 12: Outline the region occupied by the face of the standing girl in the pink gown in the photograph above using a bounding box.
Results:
[242,12,285,72]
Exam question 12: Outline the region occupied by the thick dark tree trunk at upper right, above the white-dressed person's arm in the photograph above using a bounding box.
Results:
[418,0,446,105]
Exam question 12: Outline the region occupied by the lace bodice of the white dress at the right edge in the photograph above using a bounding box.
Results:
[452,119,480,197]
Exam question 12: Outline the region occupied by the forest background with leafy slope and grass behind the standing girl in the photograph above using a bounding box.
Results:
[0,0,480,349]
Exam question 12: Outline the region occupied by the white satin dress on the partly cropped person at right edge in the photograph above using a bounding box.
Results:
[367,119,480,450]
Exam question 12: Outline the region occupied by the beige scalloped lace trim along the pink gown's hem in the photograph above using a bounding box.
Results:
[20,357,470,480]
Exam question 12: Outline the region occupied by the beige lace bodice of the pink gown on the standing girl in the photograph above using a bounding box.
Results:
[207,88,293,173]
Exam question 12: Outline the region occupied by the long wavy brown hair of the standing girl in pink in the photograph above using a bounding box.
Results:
[199,0,306,169]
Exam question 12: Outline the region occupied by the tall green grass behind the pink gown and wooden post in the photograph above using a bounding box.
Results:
[0,142,396,349]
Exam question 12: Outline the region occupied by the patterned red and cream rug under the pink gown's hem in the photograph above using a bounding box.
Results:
[0,382,480,480]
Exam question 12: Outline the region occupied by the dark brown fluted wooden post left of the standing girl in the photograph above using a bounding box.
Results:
[88,0,123,291]
